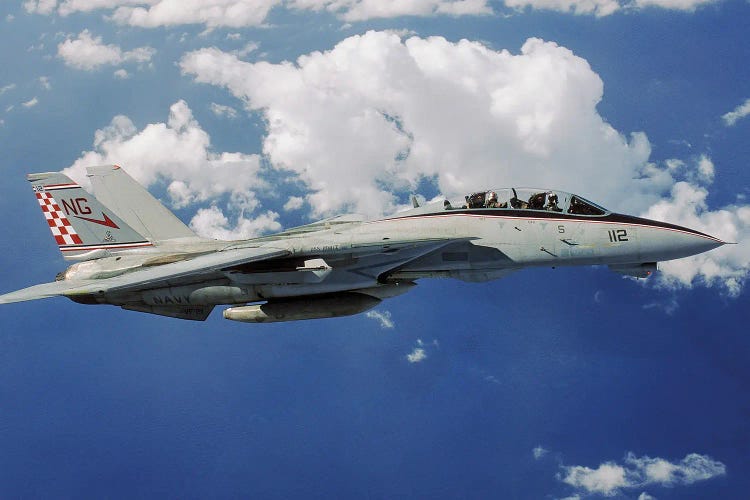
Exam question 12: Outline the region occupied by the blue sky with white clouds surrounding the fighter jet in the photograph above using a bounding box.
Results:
[0,0,750,500]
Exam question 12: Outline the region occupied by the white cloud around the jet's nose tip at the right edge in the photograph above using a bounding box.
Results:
[643,156,750,296]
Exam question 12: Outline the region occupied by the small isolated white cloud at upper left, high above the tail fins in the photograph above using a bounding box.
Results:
[57,30,156,70]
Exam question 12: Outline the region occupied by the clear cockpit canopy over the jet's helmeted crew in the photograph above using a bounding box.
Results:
[445,188,609,216]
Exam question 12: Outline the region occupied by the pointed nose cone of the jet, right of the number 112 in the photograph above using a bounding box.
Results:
[640,216,726,261]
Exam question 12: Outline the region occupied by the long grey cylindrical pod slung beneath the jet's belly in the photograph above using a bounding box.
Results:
[224,292,381,323]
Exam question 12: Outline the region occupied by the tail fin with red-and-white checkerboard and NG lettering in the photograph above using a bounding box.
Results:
[27,172,151,260]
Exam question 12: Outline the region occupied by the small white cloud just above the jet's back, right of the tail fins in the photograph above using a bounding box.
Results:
[190,205,281,240]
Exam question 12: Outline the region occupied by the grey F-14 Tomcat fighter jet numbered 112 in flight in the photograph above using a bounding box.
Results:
[0,165,724,323]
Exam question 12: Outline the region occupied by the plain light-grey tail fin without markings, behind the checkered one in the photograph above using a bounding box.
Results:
[86,165,196,241]
